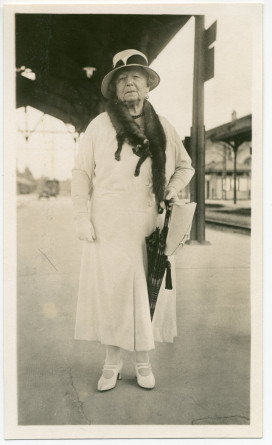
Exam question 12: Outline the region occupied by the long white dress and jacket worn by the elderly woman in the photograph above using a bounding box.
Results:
[72,113,194,351]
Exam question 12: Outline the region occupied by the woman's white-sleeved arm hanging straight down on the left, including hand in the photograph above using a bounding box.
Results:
[71,124,95,242]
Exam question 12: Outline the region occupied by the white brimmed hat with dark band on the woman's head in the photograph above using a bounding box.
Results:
[101,49,160,99]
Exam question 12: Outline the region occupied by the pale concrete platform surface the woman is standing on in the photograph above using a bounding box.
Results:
[17,197,250,425]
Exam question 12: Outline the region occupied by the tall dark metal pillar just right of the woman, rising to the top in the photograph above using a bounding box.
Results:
[191,15,206,244]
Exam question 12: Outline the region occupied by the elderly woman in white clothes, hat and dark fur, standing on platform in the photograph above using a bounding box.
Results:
[72,50,194,391]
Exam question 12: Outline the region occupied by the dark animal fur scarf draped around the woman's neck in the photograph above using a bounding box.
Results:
[106,100,166,212]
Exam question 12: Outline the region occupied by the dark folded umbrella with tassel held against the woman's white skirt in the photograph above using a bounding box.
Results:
[145,206,172,320]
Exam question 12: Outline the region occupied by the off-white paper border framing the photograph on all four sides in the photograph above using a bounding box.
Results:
[4,2,262,439]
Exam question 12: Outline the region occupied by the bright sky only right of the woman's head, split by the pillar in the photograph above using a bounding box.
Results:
[150,15,252,138]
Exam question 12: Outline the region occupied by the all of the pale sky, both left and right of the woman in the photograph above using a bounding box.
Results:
[16,15,252,180]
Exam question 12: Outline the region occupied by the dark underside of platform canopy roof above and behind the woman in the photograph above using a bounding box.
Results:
[16,14,191,132]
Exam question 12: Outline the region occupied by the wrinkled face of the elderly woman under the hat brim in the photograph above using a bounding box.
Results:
[115,68,149,105]
